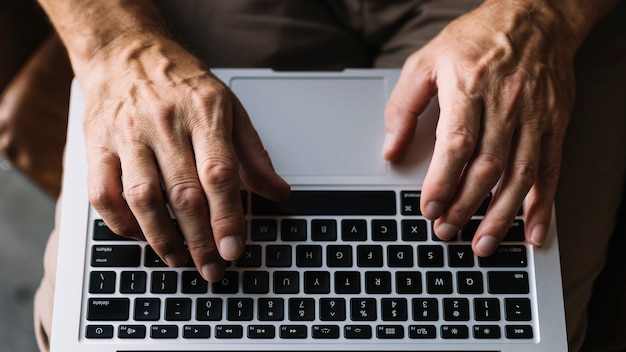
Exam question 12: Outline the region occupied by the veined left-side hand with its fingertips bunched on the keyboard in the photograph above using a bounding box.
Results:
[75,34,289,281]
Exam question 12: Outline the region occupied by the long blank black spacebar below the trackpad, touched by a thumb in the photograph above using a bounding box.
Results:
[251,191,396,215]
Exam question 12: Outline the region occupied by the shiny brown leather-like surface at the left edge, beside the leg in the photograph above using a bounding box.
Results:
[0,35,72,198]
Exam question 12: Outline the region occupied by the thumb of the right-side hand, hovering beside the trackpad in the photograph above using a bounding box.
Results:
[383,56,436,161]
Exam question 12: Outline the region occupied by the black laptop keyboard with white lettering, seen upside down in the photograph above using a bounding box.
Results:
[82,190,538,343]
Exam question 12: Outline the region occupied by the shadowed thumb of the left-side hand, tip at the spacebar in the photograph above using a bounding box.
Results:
[233,98,290,200]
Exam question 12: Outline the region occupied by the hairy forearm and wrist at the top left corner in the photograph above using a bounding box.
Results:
[39,0,166,71]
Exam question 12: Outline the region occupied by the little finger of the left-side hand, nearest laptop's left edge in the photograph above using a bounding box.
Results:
[87,133,145,240]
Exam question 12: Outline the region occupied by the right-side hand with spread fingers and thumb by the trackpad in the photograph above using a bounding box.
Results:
[383,1,579,256]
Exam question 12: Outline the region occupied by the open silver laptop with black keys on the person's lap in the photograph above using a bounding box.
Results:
[51,69,567,352]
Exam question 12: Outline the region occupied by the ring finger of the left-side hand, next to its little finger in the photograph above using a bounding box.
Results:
[120,143,189,267]
